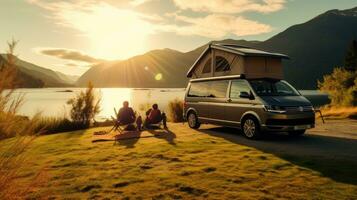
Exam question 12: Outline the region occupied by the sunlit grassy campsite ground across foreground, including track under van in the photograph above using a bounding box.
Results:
[0,120,357,199]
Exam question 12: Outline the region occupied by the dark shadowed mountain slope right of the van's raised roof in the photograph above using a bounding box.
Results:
[258,8,357,89]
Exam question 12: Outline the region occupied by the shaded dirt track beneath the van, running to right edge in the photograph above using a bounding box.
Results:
[195,120,357,160]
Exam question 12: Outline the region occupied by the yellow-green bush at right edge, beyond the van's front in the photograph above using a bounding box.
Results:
[318,68,357,107]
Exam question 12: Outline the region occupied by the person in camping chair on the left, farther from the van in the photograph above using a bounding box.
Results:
[111,101,136,132]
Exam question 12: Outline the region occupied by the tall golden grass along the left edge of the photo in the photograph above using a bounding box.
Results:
[0,40,47,199]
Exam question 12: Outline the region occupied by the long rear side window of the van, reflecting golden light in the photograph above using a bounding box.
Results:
[188,80,228,98]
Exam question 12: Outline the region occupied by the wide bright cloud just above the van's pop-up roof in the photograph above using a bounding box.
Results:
[160,14,272,38]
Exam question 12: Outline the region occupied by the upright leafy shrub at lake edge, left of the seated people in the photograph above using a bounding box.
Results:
[67,82,101,128]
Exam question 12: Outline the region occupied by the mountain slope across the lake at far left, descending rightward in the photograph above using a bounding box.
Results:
[0,54,73,88]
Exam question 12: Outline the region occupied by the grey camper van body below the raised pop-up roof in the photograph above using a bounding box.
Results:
[183,75,315,138]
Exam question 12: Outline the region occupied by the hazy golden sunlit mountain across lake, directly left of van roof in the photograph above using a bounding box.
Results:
[77,49,202,87]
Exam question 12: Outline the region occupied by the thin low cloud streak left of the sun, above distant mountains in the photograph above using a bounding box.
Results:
[36,48,105,63]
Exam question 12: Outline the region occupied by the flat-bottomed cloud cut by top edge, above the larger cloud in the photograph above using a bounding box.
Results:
[173,0,286,14]
